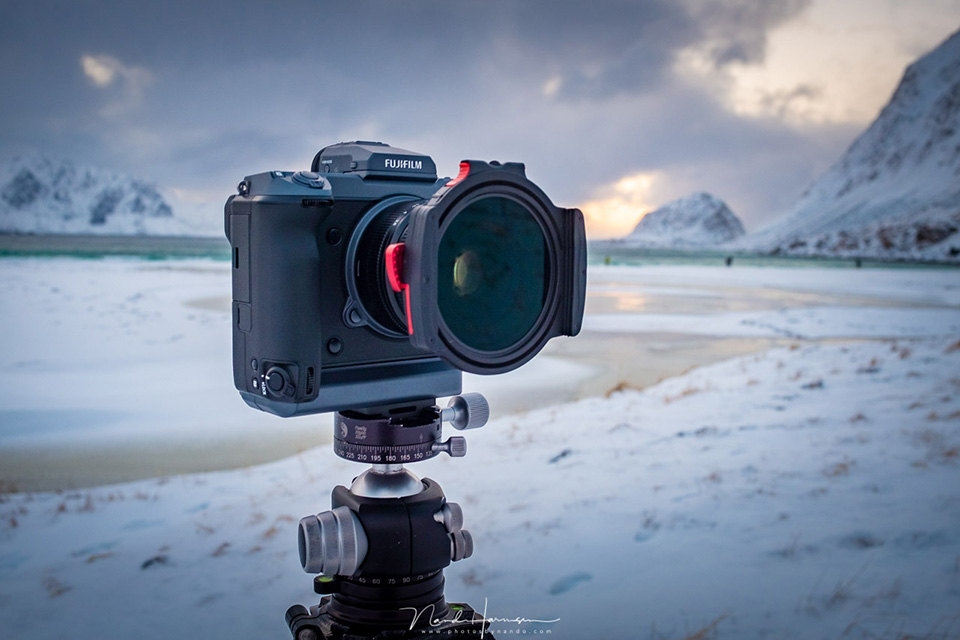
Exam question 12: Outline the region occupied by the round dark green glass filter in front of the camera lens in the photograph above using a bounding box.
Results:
[437,195,548,352]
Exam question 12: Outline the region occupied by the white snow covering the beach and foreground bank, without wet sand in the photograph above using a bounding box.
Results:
[0,260,960,639]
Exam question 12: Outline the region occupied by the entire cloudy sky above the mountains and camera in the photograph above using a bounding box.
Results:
[0,0,960,239]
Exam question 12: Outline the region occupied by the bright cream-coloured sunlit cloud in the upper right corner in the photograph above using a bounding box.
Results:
[677,0,960,131]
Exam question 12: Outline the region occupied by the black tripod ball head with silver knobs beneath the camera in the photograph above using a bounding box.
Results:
[286,394,494,640]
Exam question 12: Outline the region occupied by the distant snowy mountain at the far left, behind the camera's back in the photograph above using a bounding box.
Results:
[0,154,192,235]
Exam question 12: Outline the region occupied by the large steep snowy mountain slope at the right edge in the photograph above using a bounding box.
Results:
[736,32,960,260]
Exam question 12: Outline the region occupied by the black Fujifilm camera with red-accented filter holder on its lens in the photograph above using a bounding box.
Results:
[224,141,586,417]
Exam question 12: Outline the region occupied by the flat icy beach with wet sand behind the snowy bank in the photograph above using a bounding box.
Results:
[0,258,960,490]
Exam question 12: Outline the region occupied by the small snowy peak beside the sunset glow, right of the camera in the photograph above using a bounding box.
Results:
[623,192,744,249]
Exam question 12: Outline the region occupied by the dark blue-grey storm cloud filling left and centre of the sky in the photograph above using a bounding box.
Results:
[0,0,840,230]
